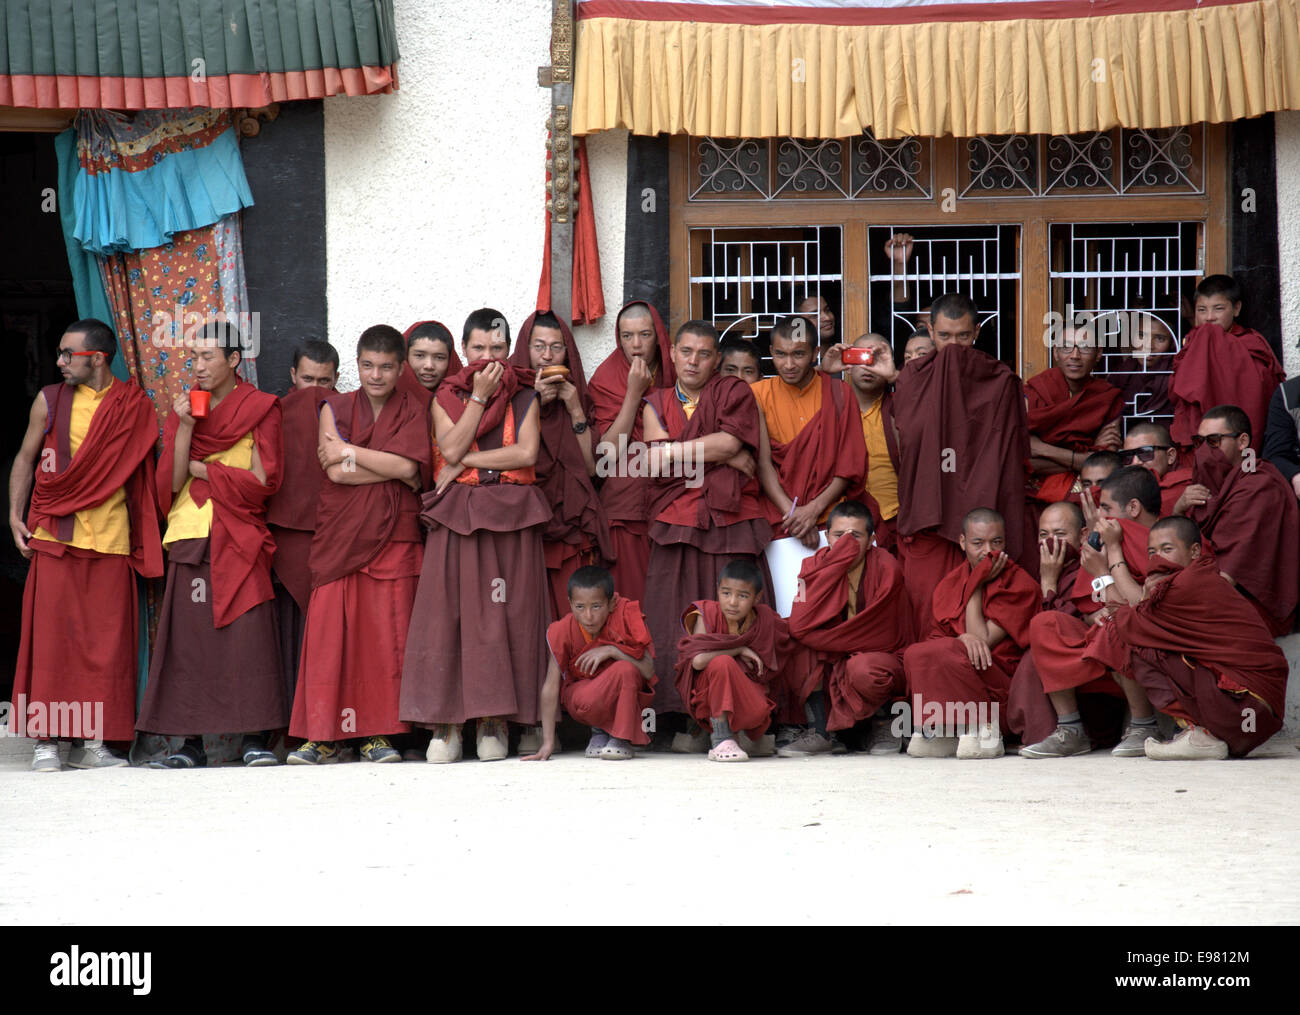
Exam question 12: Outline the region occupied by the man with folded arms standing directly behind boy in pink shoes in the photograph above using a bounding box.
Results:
[639,321,771,712]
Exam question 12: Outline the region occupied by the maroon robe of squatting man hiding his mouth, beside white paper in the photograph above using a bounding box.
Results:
[781,537,911,729]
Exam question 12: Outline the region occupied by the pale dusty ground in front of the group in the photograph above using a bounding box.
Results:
[0,738,1300,925]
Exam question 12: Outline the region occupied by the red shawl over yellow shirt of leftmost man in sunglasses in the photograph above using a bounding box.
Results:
[27,381,162,578]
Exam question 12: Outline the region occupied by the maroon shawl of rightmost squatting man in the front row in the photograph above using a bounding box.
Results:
[1089,554,1288,717]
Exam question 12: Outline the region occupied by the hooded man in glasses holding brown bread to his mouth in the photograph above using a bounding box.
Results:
[510,313,614,617]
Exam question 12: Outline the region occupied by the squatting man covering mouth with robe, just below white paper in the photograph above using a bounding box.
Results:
[779,500,911,758]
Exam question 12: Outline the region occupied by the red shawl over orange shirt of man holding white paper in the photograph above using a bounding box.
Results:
[763,372,867,525]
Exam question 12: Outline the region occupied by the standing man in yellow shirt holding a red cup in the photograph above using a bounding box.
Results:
[135,322,289,768]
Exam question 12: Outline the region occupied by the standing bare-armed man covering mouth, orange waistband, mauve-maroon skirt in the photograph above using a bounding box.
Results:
[400,308,551,764]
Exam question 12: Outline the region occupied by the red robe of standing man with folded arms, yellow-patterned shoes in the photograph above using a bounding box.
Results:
[290,390,432,741]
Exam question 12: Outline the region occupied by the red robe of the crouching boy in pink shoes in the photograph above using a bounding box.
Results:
[676,599,798,739]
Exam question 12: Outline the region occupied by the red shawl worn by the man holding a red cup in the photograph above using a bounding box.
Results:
[157,379,283,628]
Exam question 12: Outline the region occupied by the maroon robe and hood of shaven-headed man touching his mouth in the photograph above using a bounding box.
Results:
[588,300,677,602]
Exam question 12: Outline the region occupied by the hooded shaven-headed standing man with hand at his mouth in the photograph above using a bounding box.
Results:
[588,300,677,602]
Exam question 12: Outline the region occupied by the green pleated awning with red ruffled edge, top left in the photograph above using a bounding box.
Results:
[0,0,398,109]
